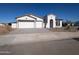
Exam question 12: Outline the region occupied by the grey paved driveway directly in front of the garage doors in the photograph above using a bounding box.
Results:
[10,28,50,34]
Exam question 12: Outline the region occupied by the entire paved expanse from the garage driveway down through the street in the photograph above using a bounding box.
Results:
[0,29,79,55]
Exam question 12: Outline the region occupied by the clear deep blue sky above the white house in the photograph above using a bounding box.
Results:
[0,3,79,23]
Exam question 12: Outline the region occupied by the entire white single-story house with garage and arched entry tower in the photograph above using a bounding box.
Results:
[12,14,62,28]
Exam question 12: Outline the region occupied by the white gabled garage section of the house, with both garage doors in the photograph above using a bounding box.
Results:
[16,14,43,28]
